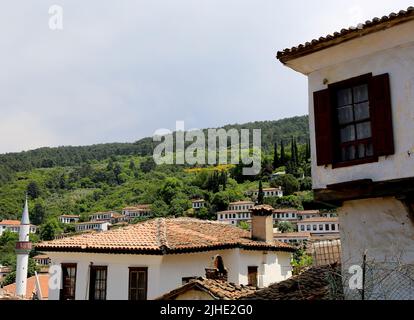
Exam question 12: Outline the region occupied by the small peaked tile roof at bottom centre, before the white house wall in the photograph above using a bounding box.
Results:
[157,278,257,300]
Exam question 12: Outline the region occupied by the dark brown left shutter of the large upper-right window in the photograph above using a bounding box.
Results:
[313,89,333,166]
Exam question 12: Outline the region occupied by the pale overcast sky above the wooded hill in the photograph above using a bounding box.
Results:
[0,0,410,153]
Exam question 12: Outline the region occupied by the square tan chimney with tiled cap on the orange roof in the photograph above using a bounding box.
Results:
[251,205,273,243]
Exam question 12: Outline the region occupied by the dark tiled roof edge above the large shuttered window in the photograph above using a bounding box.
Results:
[277,7,414,63]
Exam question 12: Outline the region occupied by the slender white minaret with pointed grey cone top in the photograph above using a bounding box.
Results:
[16,196,32,297]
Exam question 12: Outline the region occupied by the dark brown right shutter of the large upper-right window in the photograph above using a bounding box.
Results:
[369,73,394,156]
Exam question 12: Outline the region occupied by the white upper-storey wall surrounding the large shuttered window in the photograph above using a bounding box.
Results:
[304,18,414,189]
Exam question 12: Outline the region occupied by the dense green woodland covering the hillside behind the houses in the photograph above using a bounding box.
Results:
[0,116,319,282]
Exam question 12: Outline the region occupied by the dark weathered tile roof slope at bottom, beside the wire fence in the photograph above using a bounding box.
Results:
[241,265,342,300]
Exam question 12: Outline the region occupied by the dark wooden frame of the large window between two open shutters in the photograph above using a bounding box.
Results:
[328,73,378,169]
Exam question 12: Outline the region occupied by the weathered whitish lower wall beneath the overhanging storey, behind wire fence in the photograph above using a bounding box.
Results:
[339,197,414,299]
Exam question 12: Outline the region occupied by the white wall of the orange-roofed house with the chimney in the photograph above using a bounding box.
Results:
[48,249,291,300]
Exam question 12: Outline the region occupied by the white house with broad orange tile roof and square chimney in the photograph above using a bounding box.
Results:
[36,215,294,300]
